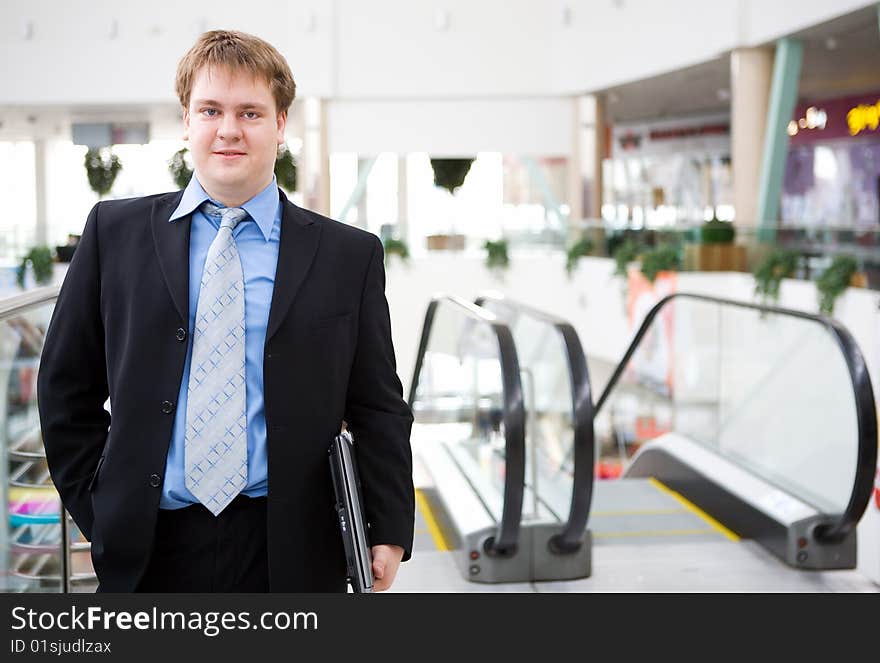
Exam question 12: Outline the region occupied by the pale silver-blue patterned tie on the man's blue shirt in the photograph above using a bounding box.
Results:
[184,201,248,516]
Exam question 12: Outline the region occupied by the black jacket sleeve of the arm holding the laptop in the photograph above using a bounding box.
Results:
[345,238,415,561]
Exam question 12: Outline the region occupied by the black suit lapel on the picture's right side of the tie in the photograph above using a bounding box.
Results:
[266,189,321,341]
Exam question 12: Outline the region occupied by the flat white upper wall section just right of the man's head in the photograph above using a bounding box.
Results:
[337,0,552,99]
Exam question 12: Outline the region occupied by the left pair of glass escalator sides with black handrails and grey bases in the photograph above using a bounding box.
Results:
[409,297,593,583]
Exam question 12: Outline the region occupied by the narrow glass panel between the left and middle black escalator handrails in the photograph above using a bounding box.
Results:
[482,299,574,521]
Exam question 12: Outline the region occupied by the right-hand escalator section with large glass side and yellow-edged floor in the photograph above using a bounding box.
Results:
[590,294,877,570]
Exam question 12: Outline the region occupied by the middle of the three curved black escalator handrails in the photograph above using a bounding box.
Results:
[474,294,596,554]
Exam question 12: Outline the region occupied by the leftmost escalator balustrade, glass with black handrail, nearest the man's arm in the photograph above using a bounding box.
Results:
[409,297,525,555]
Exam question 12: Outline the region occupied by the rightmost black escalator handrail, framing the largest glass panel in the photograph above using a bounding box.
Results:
[594,292,877,543]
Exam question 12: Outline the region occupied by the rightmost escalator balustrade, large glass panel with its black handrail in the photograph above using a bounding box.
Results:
[596,294,877,540]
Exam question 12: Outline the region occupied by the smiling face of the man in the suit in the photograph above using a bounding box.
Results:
[183,67,287,206]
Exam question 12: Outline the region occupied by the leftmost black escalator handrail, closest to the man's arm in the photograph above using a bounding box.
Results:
[409,296,526,556]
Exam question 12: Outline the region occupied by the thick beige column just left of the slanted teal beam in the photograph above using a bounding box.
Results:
[730,48,773,227]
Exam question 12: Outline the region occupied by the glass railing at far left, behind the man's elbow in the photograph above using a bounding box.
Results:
[0,287,96,592]
